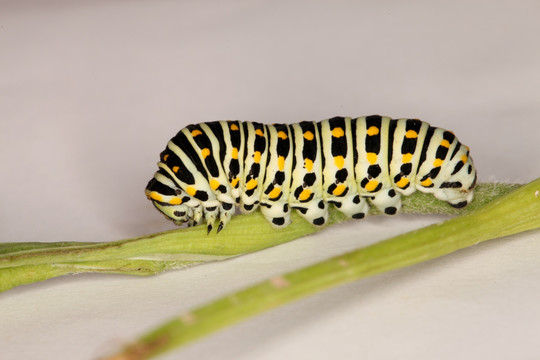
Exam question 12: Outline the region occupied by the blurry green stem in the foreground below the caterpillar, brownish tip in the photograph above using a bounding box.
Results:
[108,179,540,360]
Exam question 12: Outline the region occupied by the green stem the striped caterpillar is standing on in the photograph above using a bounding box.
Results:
[0,184,518,291]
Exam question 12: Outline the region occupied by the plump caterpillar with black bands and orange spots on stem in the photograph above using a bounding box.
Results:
[145,115,476,232]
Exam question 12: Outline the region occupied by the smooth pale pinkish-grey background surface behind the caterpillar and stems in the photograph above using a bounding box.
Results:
[0,0,540,359]
